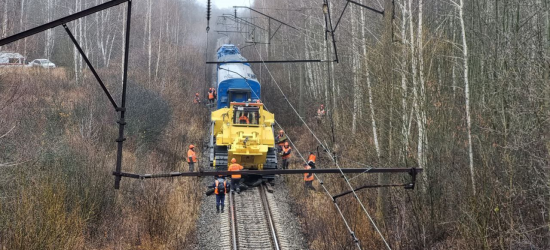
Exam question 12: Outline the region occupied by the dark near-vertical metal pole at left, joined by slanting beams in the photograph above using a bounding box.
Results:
[113,0,132,189]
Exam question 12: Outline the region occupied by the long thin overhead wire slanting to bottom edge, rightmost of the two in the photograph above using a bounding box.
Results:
[254,45,391,250]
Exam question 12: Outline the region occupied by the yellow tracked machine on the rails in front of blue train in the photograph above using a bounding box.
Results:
[210,102,277,179]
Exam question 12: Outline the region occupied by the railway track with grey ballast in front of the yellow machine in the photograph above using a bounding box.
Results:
[220,185,292,250]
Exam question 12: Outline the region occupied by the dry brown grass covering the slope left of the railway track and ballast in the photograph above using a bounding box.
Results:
[0,65,204,249]
